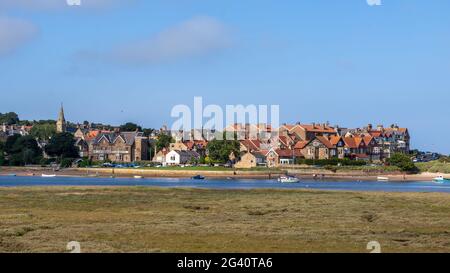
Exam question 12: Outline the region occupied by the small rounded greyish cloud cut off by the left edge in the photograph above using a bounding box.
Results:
[0,16,38,57]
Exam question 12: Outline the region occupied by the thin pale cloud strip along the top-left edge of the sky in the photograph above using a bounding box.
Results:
[0,0,137,10]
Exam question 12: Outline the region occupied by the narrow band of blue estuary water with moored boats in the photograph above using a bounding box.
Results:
[0,176,450,193]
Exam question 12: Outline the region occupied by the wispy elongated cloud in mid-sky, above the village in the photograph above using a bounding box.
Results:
[80,17,232,65]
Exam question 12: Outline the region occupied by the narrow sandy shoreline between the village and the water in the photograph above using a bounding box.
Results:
[0,167,442,182]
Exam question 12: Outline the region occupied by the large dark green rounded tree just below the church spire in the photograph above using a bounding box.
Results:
[45,133,78,159]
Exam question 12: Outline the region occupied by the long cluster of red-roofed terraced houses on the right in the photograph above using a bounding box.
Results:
[229,123,410,167]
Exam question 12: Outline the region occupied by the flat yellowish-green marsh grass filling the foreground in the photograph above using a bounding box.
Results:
[0,187,450,252]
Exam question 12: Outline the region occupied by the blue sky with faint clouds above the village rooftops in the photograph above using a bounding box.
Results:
[0,0,450,153]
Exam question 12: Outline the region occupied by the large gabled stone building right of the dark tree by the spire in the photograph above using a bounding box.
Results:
[89,132,148,162]
